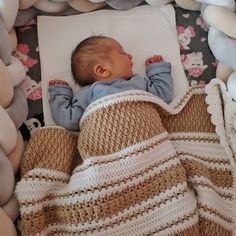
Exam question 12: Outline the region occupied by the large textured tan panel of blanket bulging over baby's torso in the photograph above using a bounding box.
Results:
[78,102,165,159]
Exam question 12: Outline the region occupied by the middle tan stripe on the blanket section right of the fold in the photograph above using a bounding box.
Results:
[181,159,233,188]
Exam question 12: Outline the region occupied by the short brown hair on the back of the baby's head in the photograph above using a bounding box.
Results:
[71,36,112,86]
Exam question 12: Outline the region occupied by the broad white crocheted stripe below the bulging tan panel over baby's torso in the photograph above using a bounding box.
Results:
[67,141,178,190]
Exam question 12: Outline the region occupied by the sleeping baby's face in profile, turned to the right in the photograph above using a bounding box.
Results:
[108,39,133,80]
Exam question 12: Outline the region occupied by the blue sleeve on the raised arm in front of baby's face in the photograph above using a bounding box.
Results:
[146,62,173,103]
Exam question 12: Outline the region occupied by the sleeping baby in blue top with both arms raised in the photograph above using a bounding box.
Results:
[48,36,173,131]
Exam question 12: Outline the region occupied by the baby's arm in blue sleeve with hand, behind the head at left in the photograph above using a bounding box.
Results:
[48,80,84,131]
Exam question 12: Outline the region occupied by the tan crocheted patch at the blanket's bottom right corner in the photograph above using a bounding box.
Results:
[199,216,233,236]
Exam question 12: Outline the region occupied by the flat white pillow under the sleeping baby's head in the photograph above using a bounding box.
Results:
[38,5,188,125]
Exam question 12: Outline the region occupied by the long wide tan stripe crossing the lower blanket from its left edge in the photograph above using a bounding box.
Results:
[22,165,185,235]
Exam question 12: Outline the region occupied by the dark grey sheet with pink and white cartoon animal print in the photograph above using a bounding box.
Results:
[16,4,217,140]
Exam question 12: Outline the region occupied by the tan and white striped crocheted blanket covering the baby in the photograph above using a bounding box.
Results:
[15,79,236,236]
